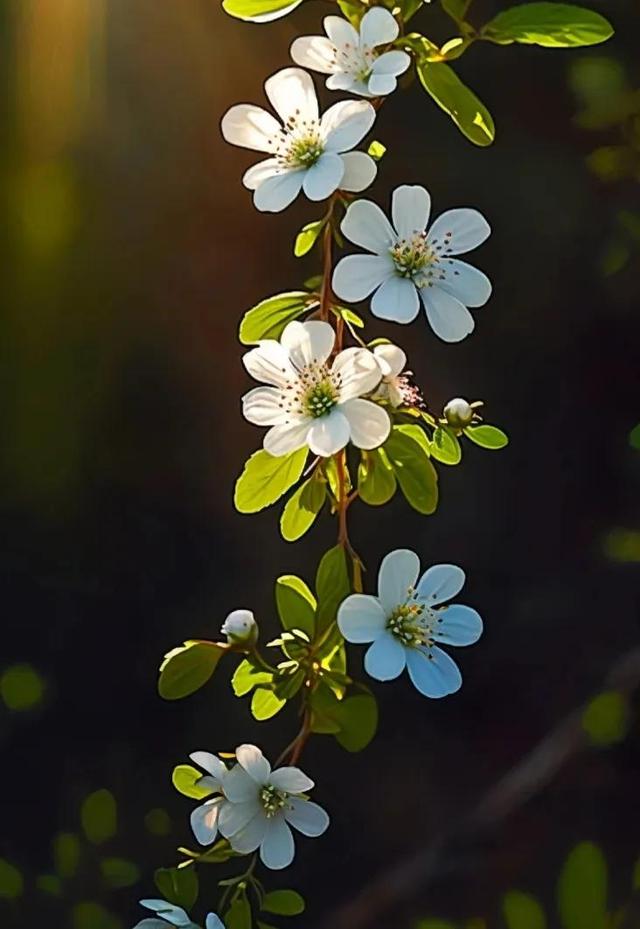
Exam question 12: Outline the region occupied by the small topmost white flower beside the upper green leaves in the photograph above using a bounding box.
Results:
[291,6,411,97]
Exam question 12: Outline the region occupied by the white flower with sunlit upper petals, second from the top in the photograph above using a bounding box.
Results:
[222,68,377,213]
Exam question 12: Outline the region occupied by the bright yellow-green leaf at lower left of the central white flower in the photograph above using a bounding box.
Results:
[233,445,309,513]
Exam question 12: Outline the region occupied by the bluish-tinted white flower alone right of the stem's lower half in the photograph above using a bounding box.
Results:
[338,549,482,697]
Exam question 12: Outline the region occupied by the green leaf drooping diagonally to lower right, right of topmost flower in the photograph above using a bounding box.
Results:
[417,58,496,145]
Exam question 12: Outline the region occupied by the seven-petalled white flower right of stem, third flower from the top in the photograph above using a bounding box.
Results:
[333,185,491,342]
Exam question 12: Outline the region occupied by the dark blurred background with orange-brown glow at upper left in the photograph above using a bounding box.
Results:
[0,0,640,929]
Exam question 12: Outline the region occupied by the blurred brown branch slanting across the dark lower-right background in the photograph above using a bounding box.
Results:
[321,649,640,929]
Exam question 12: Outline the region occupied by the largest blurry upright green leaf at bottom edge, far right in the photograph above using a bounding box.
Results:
[558,842,607,929]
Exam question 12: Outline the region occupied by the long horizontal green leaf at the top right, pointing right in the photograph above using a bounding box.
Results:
[481,3,613,48]
